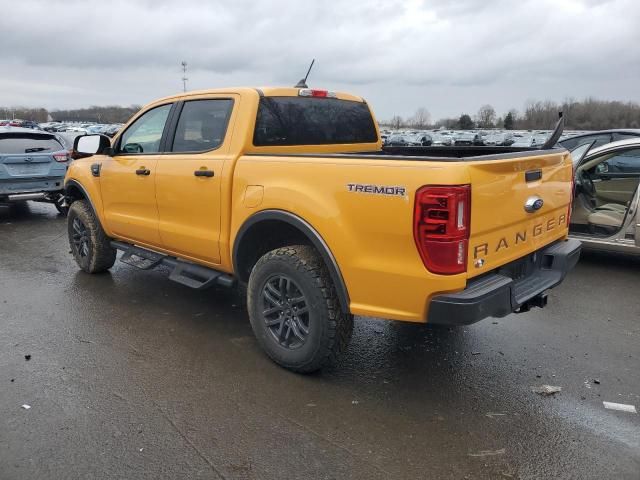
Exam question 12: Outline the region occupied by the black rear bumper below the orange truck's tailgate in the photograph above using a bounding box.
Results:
[428,239,581,325]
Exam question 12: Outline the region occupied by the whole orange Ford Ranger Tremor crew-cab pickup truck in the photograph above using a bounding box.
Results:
[65,88,580,372]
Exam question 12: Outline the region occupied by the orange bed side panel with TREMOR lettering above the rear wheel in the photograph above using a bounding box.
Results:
[231,155,469,322]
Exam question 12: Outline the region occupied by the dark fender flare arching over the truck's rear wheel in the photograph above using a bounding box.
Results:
[232,210,350,313]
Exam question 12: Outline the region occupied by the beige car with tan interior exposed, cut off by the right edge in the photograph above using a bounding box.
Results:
[569,138,640,254]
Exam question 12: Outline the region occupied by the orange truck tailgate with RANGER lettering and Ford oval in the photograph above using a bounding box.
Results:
[467,151,573,277]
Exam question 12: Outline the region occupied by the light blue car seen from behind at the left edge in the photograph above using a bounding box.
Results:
[0,127,71,213]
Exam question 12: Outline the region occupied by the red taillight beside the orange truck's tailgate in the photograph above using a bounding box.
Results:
[413,185,471,275]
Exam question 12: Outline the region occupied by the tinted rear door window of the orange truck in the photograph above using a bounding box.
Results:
[171,98,233,153]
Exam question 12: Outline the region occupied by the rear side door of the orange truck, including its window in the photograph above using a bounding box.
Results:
[156,95,239,264]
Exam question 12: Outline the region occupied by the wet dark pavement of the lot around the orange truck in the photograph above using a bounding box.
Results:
[0,203,640,480]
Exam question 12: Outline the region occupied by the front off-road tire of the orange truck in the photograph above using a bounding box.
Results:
[67,200,116,273]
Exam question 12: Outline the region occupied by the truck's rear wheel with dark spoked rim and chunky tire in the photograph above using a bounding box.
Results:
[247,245,353,373]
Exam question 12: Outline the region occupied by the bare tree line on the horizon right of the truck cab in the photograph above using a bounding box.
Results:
[380,98,640,130]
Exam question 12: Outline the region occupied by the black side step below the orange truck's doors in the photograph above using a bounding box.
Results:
[111,240,235,290]
